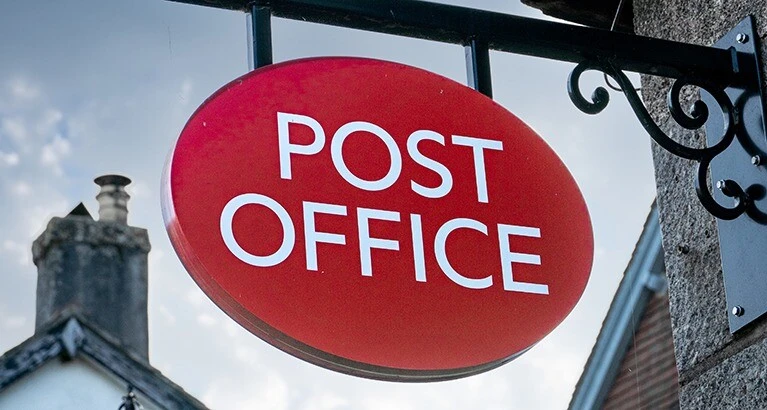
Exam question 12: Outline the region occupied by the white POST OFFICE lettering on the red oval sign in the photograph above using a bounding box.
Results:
[220,112,549,295]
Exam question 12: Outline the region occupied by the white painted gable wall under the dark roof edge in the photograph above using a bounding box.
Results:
[0,359,159,410]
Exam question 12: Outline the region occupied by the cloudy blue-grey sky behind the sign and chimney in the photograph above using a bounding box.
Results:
[0,0,655,410]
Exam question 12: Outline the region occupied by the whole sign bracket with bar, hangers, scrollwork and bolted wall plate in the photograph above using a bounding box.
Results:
[166,0,767,332]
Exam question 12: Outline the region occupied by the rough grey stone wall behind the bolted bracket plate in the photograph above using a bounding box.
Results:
[633,0,767,409]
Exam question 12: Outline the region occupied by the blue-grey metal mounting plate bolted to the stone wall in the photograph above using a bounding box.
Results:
[701,17,767,333]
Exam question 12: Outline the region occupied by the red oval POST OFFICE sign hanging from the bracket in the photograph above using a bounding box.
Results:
[163,58,593,381]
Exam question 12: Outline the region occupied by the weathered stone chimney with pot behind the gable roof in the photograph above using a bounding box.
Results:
[32,175,150,361]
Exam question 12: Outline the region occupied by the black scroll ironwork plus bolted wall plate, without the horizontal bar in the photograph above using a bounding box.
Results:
[568,17,767,333]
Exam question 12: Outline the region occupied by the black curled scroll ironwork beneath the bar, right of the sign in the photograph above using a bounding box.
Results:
[567,61,752,220]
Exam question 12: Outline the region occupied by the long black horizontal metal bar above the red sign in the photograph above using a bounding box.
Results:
[171,0,740,85]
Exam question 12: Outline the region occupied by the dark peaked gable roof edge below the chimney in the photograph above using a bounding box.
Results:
[0,315,207,409]
